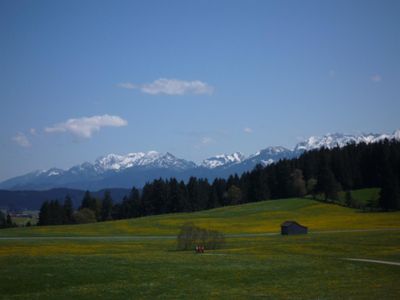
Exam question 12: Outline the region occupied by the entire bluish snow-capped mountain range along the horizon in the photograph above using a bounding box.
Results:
[0,129,400,190]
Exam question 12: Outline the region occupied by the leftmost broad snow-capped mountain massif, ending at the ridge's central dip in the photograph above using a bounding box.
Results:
[0,151,197,190]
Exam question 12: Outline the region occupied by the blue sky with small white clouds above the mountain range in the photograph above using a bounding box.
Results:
[0,0,400,181]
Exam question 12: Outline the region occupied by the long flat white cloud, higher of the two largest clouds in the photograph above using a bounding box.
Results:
[117,78,214,95]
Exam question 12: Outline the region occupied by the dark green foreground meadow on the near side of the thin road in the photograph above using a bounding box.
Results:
[0,231,400,299]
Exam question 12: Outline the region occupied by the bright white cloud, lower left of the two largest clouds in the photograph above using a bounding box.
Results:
[45,115,128,138]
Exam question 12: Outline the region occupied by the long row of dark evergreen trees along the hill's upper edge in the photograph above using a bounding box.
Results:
[39,140,400,225]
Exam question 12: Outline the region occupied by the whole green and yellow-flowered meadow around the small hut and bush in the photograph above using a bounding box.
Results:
[0,199,400,299]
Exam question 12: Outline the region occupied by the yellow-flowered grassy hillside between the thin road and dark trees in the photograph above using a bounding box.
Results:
[0,198,400,237]
